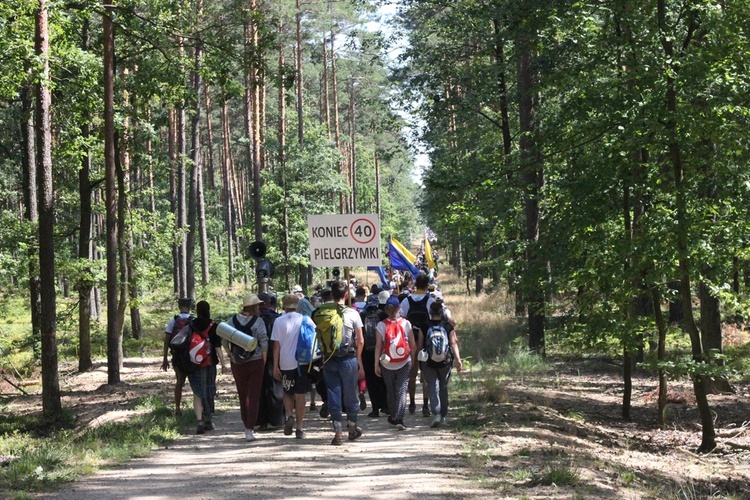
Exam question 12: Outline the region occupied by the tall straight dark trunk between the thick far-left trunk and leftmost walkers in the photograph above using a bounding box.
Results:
[102,0,122,384]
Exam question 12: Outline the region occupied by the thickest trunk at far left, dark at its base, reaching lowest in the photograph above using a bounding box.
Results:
[34,0,62,419]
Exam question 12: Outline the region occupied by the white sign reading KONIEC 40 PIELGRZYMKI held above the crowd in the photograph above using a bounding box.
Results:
[307,214,382,267]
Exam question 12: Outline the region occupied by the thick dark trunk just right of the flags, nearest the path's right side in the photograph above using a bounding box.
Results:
[518,41,546,355]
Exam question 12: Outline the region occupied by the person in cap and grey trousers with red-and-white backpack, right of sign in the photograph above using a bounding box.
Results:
[375,296,417,430]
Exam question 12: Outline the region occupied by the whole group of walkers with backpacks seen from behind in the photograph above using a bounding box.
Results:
[162,273,462,445]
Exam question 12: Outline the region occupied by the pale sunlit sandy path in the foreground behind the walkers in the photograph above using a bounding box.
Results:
[44,398,486,500]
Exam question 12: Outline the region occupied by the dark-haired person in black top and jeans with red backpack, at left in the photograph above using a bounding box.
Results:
[185,300,227,434]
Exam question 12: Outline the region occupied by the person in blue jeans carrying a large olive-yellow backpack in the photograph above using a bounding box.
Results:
[312,281,365,446]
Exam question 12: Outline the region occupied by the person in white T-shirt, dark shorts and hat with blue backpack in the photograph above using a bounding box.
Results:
[271,294,315,439]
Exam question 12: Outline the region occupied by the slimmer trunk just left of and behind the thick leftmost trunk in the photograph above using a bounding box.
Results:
[21,87,42,360]
